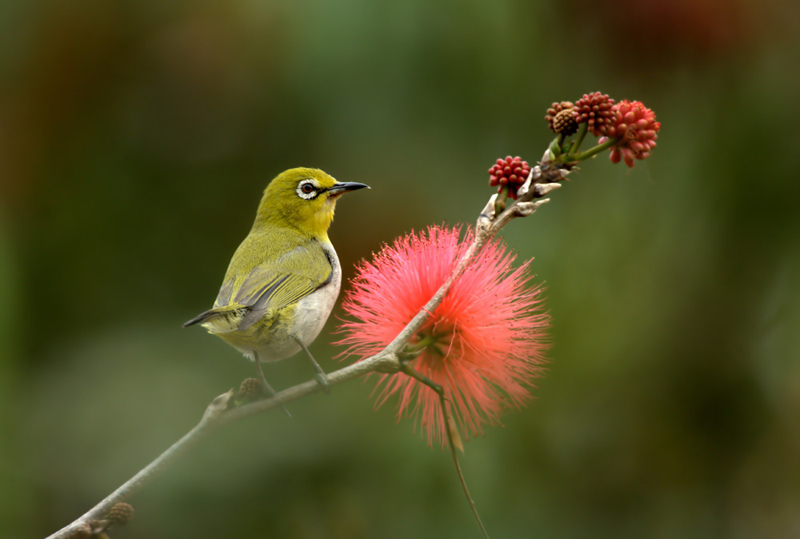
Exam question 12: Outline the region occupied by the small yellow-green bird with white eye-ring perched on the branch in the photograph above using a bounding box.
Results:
[184,168,369,395]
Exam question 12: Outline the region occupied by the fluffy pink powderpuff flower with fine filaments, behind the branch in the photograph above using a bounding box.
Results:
[337,226,549,445]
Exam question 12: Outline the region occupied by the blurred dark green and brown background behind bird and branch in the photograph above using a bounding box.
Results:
[0,0,800,538]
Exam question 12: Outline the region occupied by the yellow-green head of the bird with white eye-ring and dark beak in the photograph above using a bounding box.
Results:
[254,168,369,237]
